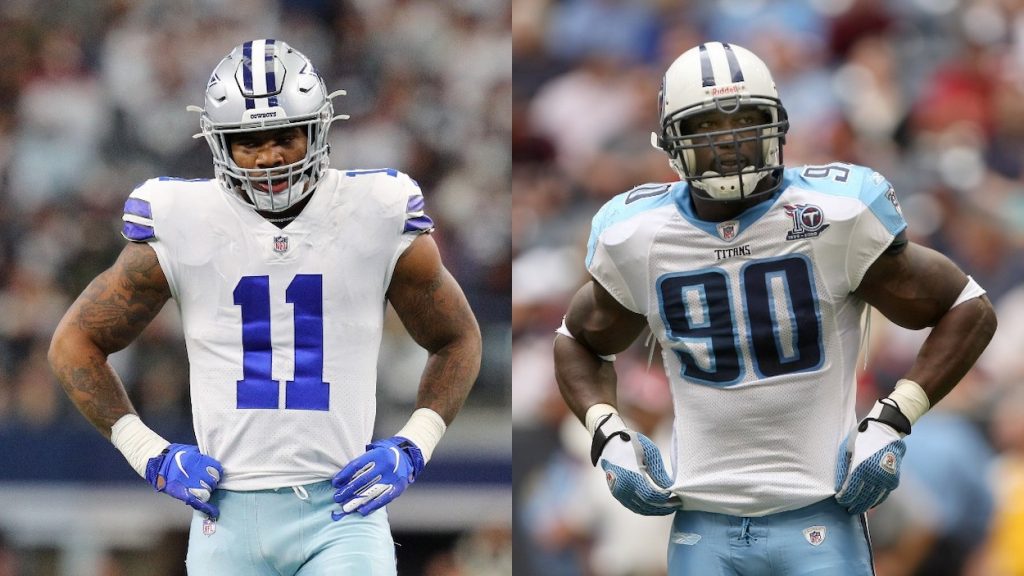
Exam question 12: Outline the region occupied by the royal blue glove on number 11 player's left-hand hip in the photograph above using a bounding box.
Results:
[145,444,224,520]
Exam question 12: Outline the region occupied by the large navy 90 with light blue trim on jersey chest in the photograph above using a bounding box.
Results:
[657,256,824,386]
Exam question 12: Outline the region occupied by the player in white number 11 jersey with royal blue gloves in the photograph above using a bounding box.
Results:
[49,39,481,576]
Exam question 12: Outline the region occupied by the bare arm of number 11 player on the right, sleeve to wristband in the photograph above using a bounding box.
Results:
[387,235,481,424]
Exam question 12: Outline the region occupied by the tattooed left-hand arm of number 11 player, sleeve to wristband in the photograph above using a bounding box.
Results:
[48,243,171,439]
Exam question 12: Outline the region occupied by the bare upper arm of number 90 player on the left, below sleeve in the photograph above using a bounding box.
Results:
[565,280,647,355]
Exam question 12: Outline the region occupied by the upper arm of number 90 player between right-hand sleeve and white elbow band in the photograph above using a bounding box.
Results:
[855,237,967,329]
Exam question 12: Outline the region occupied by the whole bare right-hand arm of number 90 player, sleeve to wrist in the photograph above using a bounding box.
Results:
[855,243,996,406]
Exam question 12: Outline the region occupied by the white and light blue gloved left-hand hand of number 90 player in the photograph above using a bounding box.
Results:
[591,414,682,516]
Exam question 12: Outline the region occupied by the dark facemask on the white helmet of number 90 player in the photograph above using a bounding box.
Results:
[658,96,788,201]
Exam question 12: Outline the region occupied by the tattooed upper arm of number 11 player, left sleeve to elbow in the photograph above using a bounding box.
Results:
[55,242,171,354]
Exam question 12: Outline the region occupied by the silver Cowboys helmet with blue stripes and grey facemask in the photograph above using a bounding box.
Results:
[188,38,348,212]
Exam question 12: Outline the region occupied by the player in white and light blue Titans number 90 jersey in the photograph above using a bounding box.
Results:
[554,42,996,576]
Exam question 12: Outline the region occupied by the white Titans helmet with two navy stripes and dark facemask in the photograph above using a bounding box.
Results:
[651,42,790,200]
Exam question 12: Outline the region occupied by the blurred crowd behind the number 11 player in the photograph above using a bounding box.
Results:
[0,0,512,575]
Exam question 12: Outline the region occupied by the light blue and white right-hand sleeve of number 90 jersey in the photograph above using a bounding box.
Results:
[846,170,906,291]
